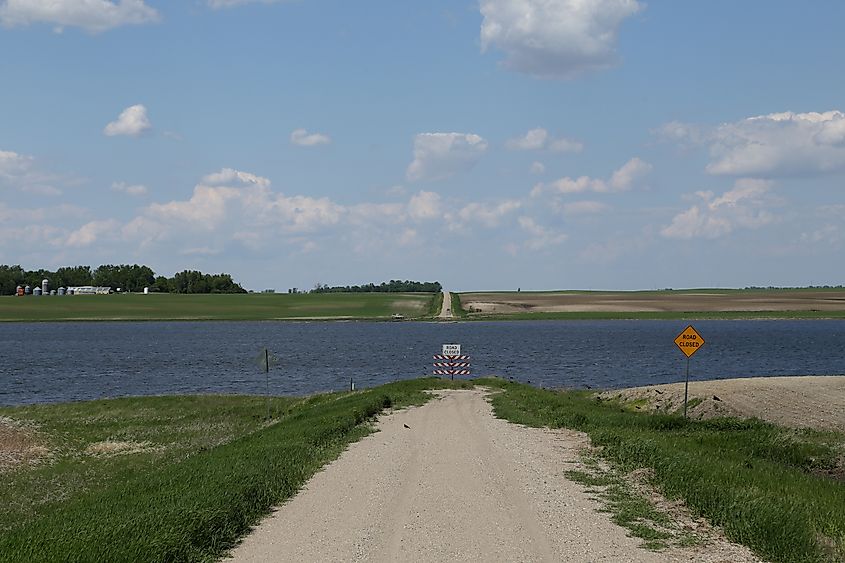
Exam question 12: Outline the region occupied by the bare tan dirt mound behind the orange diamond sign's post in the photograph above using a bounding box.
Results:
[599,375,845,432]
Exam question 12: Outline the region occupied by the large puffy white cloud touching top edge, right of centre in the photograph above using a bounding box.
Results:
[480,0,643,79]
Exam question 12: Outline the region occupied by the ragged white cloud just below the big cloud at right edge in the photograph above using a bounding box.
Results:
[660,178,776,239]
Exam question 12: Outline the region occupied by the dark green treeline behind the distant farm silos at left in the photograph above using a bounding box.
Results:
[0,264,246,295]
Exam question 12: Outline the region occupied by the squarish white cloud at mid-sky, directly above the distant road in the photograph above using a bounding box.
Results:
[406,133,487,182]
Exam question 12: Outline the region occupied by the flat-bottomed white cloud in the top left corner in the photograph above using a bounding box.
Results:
[0,0,161,33]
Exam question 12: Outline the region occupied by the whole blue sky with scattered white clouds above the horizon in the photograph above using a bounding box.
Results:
[0,0,845,290]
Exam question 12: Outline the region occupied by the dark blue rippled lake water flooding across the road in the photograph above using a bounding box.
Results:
[0,320,845,405]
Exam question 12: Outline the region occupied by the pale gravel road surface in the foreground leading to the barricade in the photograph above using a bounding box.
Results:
[227,390,755,562]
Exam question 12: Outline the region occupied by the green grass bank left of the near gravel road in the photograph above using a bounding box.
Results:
[0,378,471,562]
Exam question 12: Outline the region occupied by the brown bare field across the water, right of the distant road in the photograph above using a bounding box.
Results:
[461,290,845,314]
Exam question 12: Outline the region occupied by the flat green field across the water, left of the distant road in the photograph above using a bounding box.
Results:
[0,293,435,322]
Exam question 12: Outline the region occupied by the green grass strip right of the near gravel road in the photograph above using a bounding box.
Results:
[476,379,845,562]
